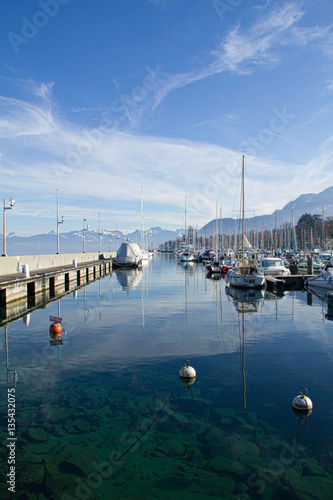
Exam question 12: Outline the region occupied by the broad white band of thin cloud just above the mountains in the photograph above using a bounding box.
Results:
[0,78,333,234]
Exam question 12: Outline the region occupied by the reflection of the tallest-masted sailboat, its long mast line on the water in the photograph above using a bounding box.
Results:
[225,287,264,410]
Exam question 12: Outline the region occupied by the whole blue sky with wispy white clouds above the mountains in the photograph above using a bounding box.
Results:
[0,0,333,235]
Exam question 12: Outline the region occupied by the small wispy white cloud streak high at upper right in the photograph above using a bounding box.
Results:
[153,2,331,109]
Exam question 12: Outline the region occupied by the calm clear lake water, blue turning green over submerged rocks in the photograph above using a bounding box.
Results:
[0,254,333,500]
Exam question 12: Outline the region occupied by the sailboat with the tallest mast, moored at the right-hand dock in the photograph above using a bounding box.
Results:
[227,155,265,288]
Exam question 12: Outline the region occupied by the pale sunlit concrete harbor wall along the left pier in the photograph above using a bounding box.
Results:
[0,252,116,276]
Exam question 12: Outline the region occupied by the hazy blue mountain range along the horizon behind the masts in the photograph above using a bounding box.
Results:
[0,186,333,255]
